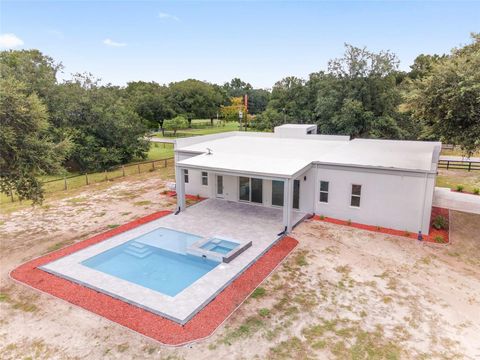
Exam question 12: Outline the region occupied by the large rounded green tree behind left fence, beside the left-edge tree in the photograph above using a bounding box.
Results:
[51,74,149,171]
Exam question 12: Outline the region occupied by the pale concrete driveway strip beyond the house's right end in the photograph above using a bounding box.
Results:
[433,187,480,214]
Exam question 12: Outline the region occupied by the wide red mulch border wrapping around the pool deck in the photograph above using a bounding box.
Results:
[11,211,298,345]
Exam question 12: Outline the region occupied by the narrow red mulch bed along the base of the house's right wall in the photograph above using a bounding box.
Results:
[313,207,450,244]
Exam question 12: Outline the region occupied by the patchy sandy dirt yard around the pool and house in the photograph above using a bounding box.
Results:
[0,173,480,359]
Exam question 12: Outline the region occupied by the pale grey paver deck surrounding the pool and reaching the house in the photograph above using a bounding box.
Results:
[40,199,305,324]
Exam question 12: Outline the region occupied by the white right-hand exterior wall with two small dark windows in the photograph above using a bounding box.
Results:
[315,165,435,234]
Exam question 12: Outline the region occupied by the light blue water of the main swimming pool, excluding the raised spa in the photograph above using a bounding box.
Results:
[82,228,219,296]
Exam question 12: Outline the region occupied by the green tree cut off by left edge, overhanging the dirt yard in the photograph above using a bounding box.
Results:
[0,77,69,204]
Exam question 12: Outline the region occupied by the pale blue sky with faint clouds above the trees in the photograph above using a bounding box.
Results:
[0,0,480,88]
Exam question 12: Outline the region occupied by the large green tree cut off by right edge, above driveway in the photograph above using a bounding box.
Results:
[408,34,480,154]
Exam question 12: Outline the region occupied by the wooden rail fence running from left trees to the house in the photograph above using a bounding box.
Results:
[2,157,175,202]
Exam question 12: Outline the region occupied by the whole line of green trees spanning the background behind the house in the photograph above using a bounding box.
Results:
[0,34,480,202]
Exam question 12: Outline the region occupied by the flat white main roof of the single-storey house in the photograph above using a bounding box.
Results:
[176,132,440,177]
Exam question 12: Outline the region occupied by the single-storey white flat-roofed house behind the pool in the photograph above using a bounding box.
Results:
[175,125,441,234]
